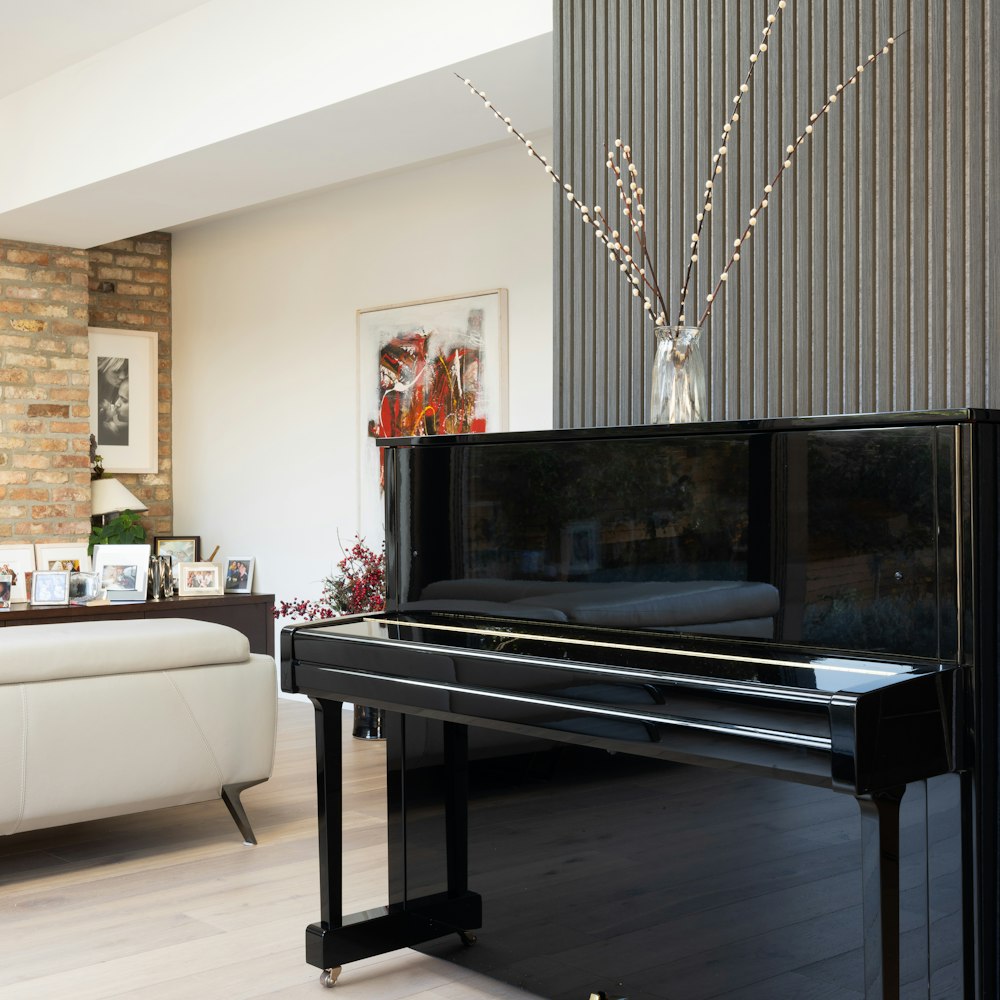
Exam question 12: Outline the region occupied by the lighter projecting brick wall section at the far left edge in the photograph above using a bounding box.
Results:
[0,240,90,542]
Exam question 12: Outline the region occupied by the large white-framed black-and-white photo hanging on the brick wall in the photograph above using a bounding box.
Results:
[89,327,159,472]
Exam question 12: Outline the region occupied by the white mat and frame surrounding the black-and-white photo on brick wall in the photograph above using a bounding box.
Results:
[89,327,159,472]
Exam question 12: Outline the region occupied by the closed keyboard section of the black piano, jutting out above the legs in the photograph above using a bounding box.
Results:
[283,612,961,795]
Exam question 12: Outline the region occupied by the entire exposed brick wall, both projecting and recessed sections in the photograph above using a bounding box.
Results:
[0,233,173,542]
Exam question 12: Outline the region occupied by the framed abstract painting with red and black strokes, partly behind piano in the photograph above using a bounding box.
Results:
[358,288,507,545]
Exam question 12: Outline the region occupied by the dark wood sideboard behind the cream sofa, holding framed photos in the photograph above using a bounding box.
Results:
[0,594,274,656]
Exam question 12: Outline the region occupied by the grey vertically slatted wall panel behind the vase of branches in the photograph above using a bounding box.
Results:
[554,0,1000,426]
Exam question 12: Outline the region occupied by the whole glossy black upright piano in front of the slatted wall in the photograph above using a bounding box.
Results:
[282,410,1000,1000]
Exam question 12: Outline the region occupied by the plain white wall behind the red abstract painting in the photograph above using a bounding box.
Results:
[173,135,552,599]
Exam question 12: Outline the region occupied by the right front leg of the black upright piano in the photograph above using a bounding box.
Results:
[856,787,905,1000]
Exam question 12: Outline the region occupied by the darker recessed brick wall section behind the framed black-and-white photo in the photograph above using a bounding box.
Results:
[89,233,174,537]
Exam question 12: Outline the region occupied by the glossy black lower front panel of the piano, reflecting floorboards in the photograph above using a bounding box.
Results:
[410,748,961,1000]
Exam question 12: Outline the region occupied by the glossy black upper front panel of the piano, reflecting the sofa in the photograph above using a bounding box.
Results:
[386,411,968,662]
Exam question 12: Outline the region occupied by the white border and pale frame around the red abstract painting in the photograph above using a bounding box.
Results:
[357,288,508,549]
